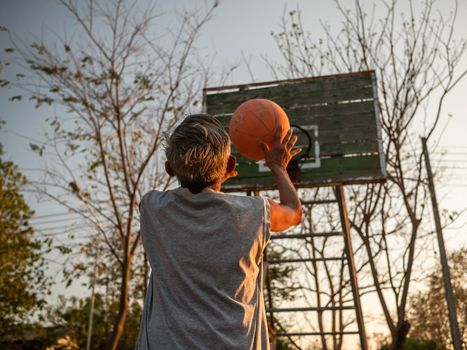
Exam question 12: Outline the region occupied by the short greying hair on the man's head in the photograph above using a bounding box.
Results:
[165,114,230,187]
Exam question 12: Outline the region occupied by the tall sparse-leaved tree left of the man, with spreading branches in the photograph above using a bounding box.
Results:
[1,0,217,349]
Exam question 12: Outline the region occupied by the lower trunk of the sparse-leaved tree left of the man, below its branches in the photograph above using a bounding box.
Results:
[107,256,131,350]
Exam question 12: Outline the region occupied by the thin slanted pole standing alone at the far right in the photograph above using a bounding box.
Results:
[422,137,462,350]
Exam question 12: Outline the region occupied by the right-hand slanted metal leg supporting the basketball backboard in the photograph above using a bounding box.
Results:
[335,185,368,350]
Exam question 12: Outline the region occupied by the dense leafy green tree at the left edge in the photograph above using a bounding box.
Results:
[0,144,50,337]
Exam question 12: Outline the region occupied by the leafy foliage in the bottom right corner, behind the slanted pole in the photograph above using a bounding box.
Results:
[409,248,467,349]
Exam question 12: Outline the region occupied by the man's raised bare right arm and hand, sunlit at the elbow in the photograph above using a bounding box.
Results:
[260,128,302,232]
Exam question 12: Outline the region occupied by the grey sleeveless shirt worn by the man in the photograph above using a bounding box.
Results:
[136,188,271,350]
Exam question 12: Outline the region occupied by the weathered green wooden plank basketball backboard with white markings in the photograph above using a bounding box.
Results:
[203,71,386,192]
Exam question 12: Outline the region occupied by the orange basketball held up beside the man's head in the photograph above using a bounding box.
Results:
[229,98,290,160]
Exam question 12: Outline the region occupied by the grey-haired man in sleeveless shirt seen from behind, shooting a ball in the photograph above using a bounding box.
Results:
[136,115,302,350]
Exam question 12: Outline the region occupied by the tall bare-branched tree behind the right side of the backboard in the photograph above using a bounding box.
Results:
[269,0,467,349]
